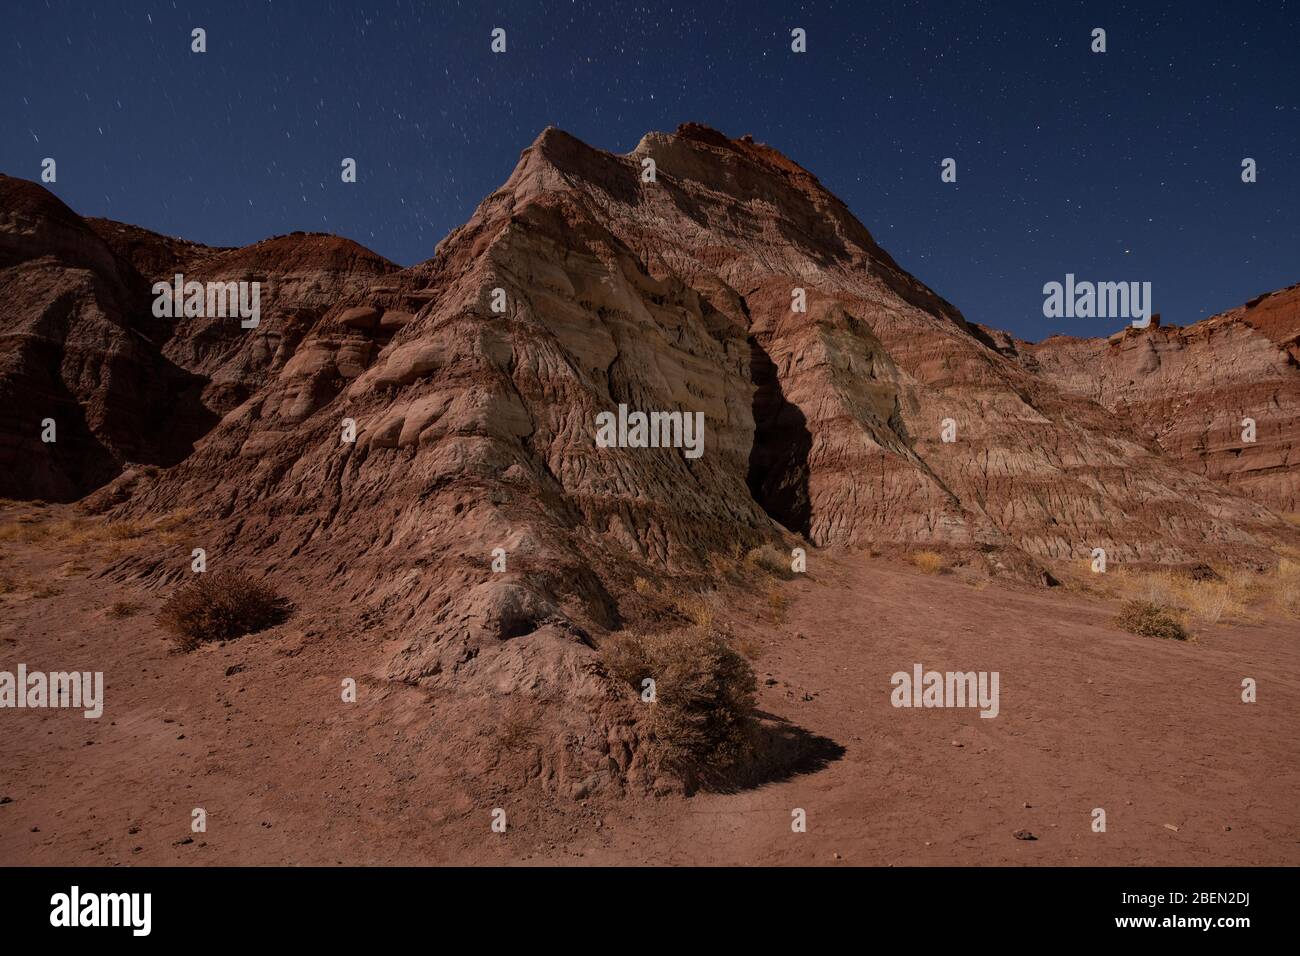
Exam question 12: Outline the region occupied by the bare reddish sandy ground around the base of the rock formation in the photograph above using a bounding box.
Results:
[0,506,1300,865]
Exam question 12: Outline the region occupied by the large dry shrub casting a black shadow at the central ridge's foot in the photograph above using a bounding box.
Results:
[601,631,758,773]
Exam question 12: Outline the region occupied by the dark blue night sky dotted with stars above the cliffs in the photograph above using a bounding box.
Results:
[0,0,1300,338]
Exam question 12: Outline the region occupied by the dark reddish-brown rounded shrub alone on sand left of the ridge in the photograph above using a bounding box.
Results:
[157,571,291,650]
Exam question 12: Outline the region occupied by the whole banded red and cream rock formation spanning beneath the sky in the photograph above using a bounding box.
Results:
[0,126,1295,786]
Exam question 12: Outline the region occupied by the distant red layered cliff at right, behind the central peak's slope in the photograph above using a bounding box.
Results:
[1010,286,1300,512]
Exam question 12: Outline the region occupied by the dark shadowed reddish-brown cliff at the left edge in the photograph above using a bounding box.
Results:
[0,177,208,501]
